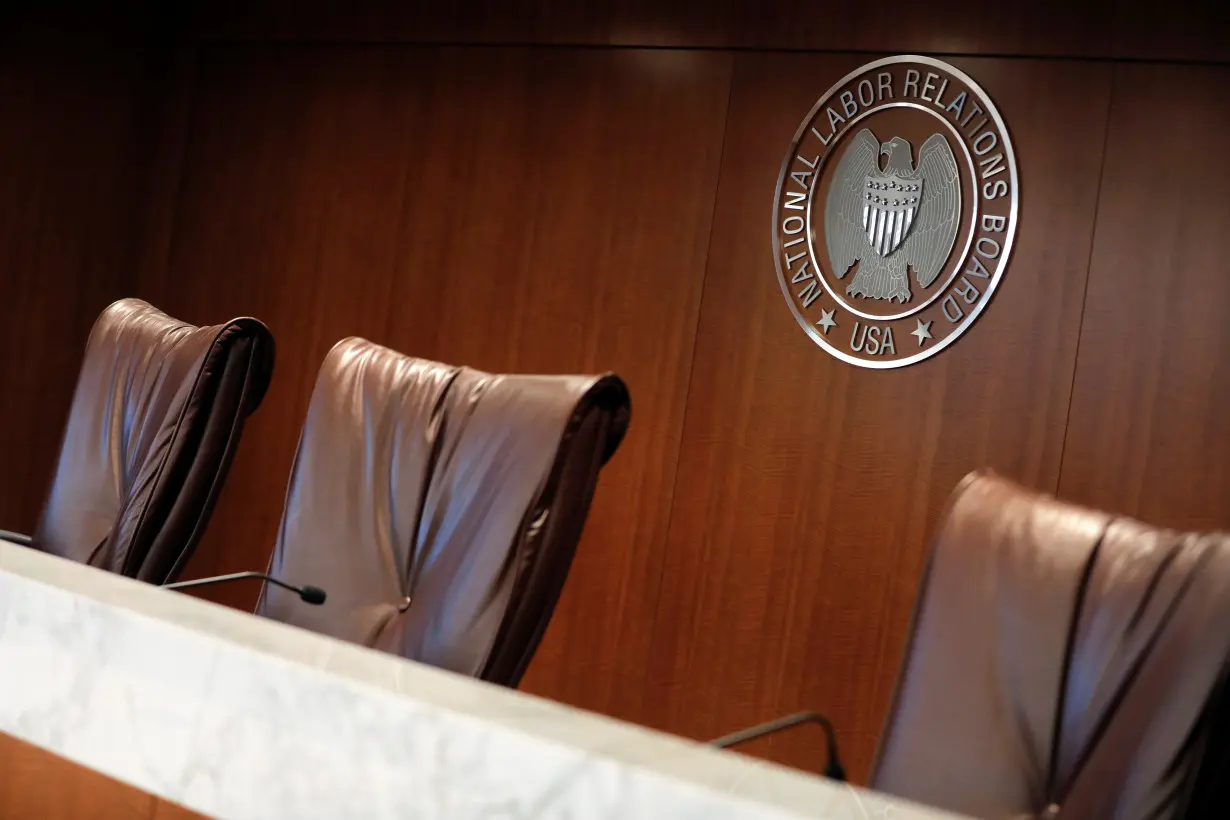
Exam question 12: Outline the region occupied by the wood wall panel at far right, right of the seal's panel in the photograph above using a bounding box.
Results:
[1060,65,1230,529]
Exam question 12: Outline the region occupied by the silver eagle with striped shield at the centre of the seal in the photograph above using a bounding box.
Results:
[824,128,961,304]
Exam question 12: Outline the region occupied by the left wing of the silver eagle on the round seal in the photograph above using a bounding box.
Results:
[824,128,879,279]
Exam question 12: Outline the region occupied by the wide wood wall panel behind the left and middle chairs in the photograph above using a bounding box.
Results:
[139,47,731,716]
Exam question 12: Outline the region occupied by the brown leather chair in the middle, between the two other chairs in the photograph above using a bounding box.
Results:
[257,338,630,686]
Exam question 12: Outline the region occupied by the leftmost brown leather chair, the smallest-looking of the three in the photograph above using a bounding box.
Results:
[33,299,274,584]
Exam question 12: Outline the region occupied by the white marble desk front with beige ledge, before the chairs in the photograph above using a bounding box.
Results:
[0,541,951,820]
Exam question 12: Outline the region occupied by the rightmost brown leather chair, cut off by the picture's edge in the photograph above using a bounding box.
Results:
[872,475,1230,820]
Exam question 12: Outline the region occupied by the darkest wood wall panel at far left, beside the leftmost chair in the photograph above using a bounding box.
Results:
[0,11,153,532]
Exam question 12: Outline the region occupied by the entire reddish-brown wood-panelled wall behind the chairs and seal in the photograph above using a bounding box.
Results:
[9,0,1230,786]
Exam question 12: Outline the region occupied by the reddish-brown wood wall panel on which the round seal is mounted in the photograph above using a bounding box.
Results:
[645,54,1111,775]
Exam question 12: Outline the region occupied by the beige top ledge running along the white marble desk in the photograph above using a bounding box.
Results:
[0,541,952,820]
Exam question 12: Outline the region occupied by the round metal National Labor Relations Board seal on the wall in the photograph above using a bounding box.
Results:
[772,57,1020,369]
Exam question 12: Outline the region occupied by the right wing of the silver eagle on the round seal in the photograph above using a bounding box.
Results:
[898,134,961,288]
